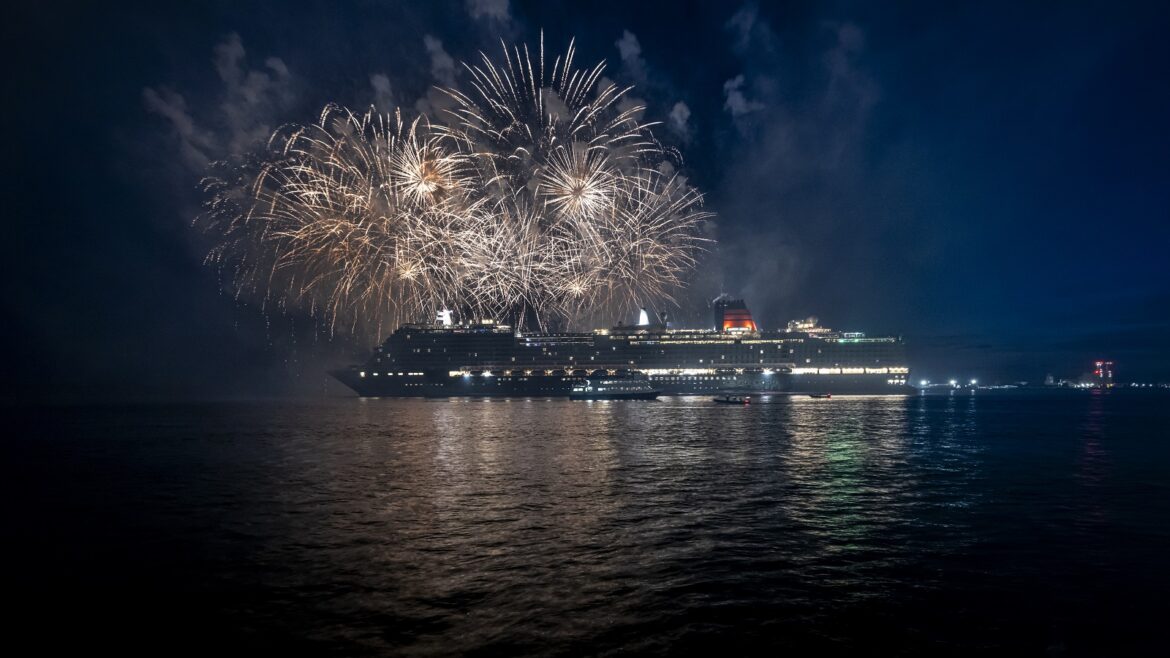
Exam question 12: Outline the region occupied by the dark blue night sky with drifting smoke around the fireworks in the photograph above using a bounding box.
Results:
[2,0,1170,399]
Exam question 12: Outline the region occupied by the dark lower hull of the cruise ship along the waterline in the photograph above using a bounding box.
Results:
[332,369,915,397]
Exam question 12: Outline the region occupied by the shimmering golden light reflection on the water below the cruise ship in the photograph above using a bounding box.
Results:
[336,388,996,632]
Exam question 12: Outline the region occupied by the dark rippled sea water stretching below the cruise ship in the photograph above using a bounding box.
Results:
[4,392,1170,656]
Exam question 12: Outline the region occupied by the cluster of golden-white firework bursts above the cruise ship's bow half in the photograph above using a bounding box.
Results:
[201,37,711,334]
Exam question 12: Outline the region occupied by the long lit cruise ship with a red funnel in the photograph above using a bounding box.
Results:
[332,296,915,397]
